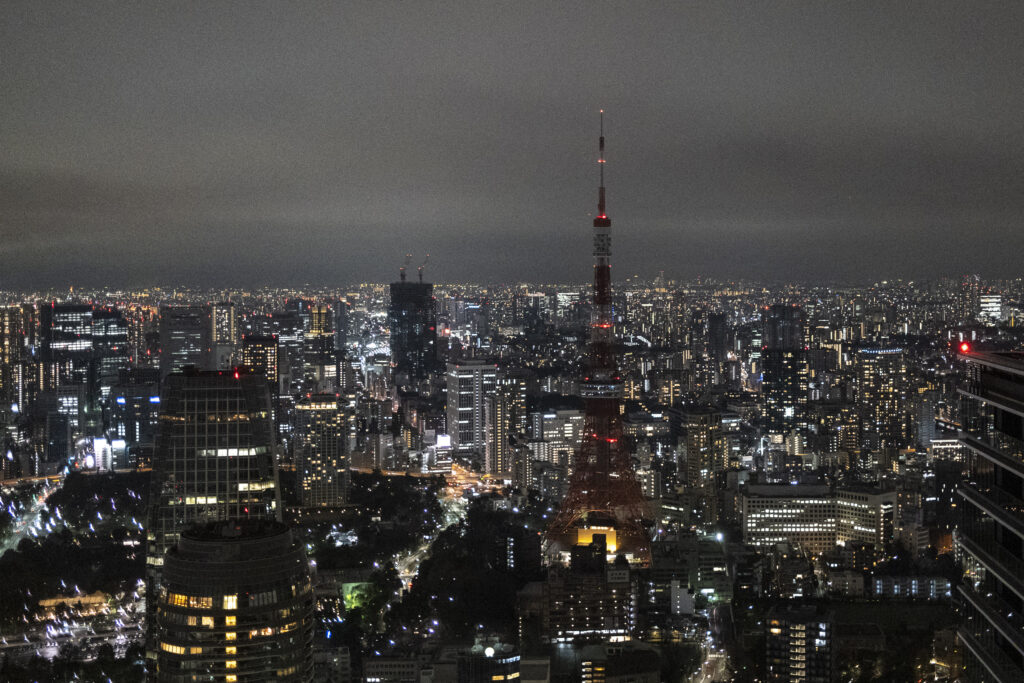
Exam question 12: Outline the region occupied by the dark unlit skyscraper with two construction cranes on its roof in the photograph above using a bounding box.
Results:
[388,273,437,386]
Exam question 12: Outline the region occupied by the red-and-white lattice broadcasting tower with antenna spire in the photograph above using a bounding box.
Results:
[547,112,650,560]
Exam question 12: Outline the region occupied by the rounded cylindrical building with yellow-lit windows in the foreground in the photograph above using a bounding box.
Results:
[156,520,313,683]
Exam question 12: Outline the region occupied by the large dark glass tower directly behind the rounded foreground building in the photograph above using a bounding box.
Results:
[146,370,281,647]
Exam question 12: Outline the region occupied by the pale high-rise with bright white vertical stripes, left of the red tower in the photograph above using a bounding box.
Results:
[446,360,498,458]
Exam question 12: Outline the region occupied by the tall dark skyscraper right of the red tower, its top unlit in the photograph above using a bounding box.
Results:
[761,304,807,442]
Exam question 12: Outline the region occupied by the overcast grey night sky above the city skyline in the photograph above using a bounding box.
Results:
[0,2,1024,289]
